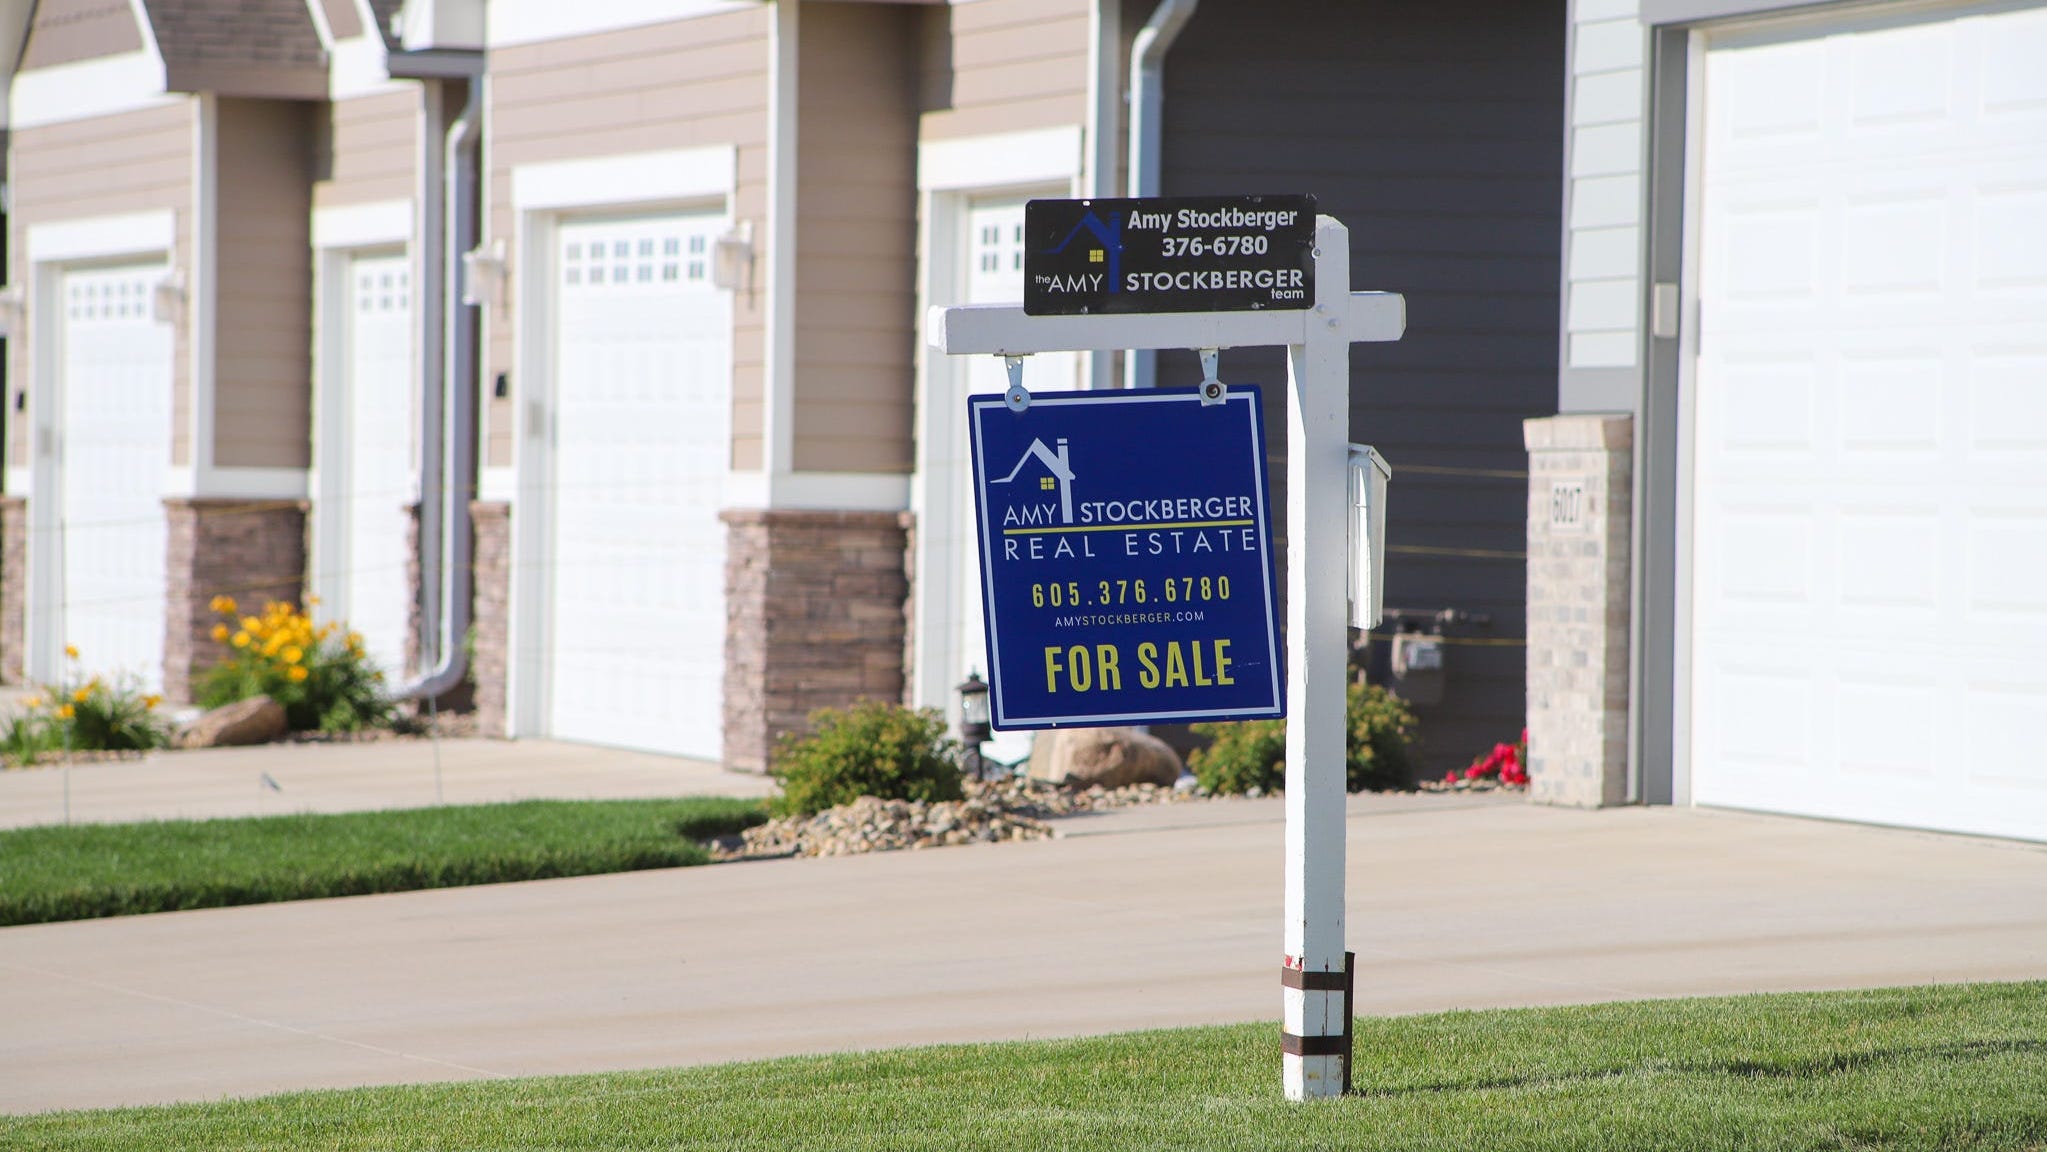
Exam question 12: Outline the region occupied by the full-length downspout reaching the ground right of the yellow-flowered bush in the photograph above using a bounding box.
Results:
[391,72,483,700]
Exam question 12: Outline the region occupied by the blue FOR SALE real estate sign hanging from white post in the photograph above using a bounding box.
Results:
[968,385,1286,730]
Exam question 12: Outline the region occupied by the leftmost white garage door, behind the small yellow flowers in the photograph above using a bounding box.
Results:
[57,266,172,690]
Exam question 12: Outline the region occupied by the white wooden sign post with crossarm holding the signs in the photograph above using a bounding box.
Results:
[925,217,1406,1101]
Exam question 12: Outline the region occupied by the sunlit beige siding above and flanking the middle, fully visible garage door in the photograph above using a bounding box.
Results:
[485,4,774,469]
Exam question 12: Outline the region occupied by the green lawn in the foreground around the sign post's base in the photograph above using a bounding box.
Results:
[0,982,2047,1152]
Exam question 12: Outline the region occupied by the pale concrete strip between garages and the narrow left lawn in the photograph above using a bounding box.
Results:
[0,739,774,829]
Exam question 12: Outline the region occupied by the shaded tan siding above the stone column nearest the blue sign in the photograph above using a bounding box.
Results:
[794,4,917,473]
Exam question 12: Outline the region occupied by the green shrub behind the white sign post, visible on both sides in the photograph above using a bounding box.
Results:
[1187,683,1417,792]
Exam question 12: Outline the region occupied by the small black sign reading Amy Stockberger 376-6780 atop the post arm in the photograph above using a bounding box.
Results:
[1024,196,1314,315]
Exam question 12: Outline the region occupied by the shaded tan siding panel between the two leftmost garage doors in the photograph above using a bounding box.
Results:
[213,100,315,469]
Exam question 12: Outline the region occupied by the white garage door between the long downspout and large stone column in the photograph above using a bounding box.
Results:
[551,215,733,759]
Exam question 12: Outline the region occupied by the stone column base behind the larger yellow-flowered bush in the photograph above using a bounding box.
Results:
[164,499,307,702]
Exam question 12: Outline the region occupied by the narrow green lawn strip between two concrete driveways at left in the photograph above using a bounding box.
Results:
[0,796,766,925]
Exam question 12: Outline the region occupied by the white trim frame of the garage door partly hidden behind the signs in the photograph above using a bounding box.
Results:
[909,125,1107,722]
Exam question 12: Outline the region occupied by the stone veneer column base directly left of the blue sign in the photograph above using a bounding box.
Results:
[723,509,909,771]
